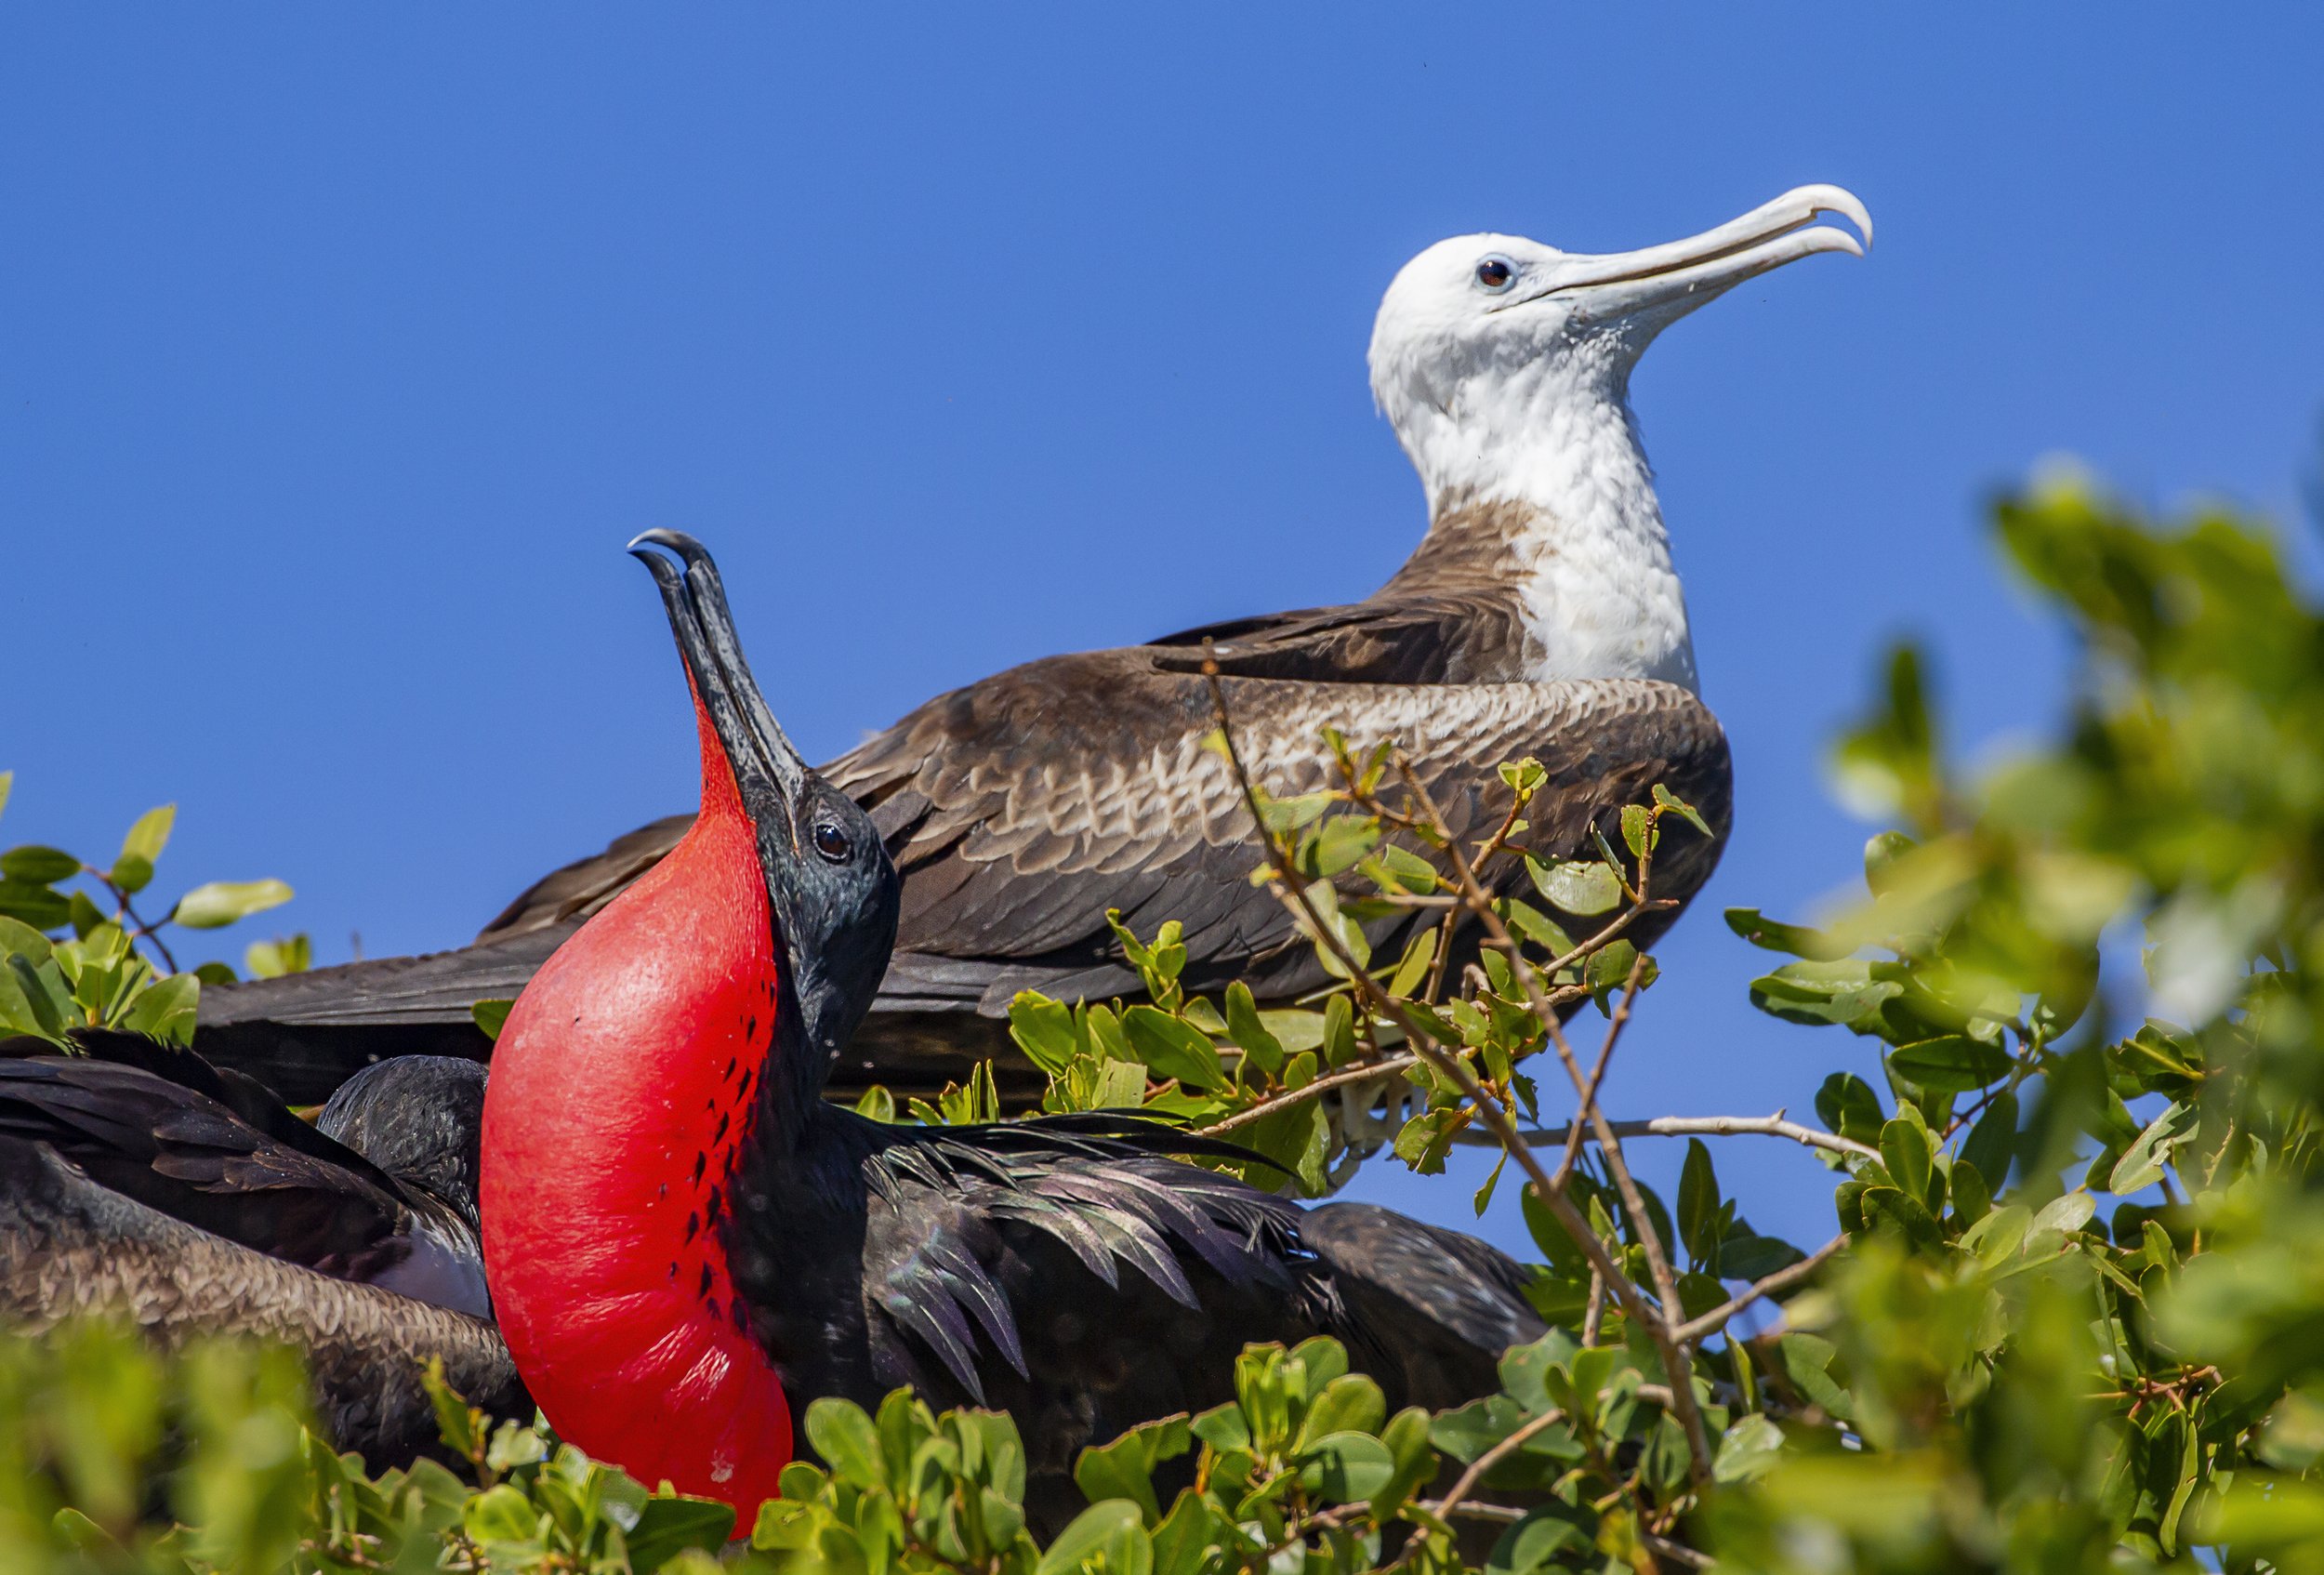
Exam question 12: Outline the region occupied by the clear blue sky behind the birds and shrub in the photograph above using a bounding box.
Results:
[13,5,2324,1243]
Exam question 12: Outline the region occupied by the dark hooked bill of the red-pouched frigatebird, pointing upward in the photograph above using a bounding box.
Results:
[630,530,807,857]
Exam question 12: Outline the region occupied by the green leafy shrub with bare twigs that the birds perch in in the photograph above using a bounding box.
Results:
[0,485,2324,1575]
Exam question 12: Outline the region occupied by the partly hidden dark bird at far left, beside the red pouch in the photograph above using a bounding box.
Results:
[0,1034,518,1468]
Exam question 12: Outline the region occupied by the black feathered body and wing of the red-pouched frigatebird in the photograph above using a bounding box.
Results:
[723,1108,1543,1515]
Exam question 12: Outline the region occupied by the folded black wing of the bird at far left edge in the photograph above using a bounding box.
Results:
[0,1034,488,1313]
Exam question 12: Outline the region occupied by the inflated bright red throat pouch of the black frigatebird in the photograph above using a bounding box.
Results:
[479,693,793,1522]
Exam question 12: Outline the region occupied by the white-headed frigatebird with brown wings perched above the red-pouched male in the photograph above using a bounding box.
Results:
[200,186,1871,1099]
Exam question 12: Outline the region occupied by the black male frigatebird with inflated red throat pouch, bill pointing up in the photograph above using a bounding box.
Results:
[482,532,1541,1529]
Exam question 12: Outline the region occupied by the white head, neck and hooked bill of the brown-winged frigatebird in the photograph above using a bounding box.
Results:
[1371,186,1873,690]
